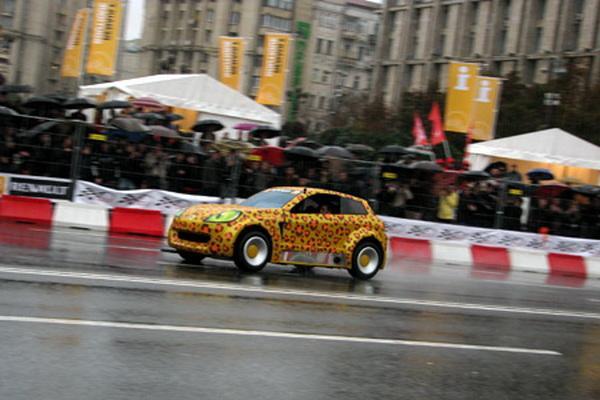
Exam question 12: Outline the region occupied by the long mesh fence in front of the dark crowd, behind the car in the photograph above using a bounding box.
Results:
[0,116,600,239]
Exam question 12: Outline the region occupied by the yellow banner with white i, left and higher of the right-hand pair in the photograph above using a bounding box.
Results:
[444,62,479,133]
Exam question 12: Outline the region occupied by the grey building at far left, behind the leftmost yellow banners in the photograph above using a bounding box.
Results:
[0,0,88,93]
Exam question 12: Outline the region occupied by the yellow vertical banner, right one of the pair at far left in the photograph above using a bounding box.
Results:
[86,0,123,76]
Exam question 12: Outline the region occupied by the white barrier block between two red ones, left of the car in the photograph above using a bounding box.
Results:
[53,202,108,231]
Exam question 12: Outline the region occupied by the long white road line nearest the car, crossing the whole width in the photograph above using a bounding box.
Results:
[0,266,600,320]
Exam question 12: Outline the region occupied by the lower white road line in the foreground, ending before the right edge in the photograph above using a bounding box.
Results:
[0,315,562,356]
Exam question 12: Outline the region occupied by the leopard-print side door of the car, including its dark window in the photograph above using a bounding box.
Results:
[281,193,340,265]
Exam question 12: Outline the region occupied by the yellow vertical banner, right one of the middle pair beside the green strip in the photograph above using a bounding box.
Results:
[256,33,290,106]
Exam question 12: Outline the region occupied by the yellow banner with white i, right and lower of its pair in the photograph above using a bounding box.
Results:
[471,76,502,140]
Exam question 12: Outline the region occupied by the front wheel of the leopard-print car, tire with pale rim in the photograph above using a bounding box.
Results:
[233,230,272,272]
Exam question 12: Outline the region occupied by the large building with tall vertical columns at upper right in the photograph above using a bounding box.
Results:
[372,0,600,106]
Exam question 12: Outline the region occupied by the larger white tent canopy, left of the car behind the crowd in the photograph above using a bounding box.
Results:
[79,74,281,128]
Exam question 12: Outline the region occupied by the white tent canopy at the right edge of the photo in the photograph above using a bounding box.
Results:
[468,128,600,170]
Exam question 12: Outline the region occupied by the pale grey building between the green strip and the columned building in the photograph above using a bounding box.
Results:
[299,0,380,131]
